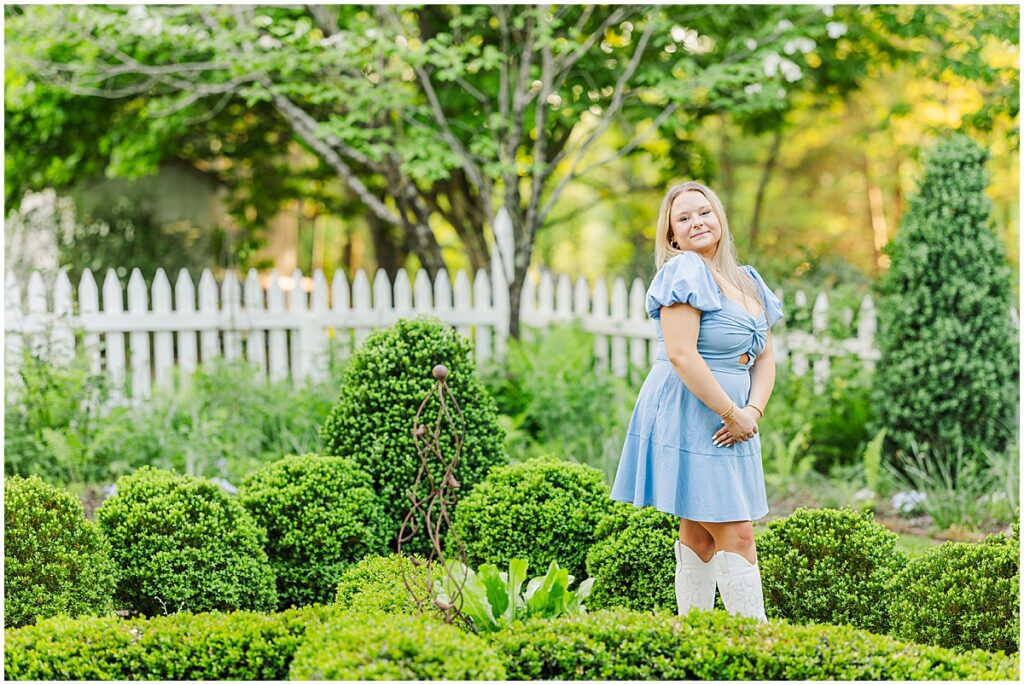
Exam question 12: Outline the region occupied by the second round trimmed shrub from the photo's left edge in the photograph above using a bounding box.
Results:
[96,466,278,615]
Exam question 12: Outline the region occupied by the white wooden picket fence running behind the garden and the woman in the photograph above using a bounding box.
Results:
[4,262,878,402]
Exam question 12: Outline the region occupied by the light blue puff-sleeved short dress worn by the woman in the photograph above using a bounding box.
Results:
[611,252,782,521]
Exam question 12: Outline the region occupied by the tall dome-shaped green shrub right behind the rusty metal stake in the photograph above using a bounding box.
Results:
[321,316,508,554]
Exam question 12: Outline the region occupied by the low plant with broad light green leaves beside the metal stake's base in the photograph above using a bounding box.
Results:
[435,559,594,633]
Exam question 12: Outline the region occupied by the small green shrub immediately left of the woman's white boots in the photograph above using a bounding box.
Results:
[587,502,679,611]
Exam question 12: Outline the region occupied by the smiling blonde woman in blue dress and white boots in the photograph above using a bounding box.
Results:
[611,181,782,622]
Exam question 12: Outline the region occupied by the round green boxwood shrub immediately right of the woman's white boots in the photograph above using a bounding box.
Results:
[757,507,906,633]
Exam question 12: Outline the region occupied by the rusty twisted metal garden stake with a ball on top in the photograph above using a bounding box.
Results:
[398,365,472,625]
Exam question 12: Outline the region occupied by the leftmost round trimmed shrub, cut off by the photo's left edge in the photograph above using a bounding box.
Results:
[3,476,115,627]
